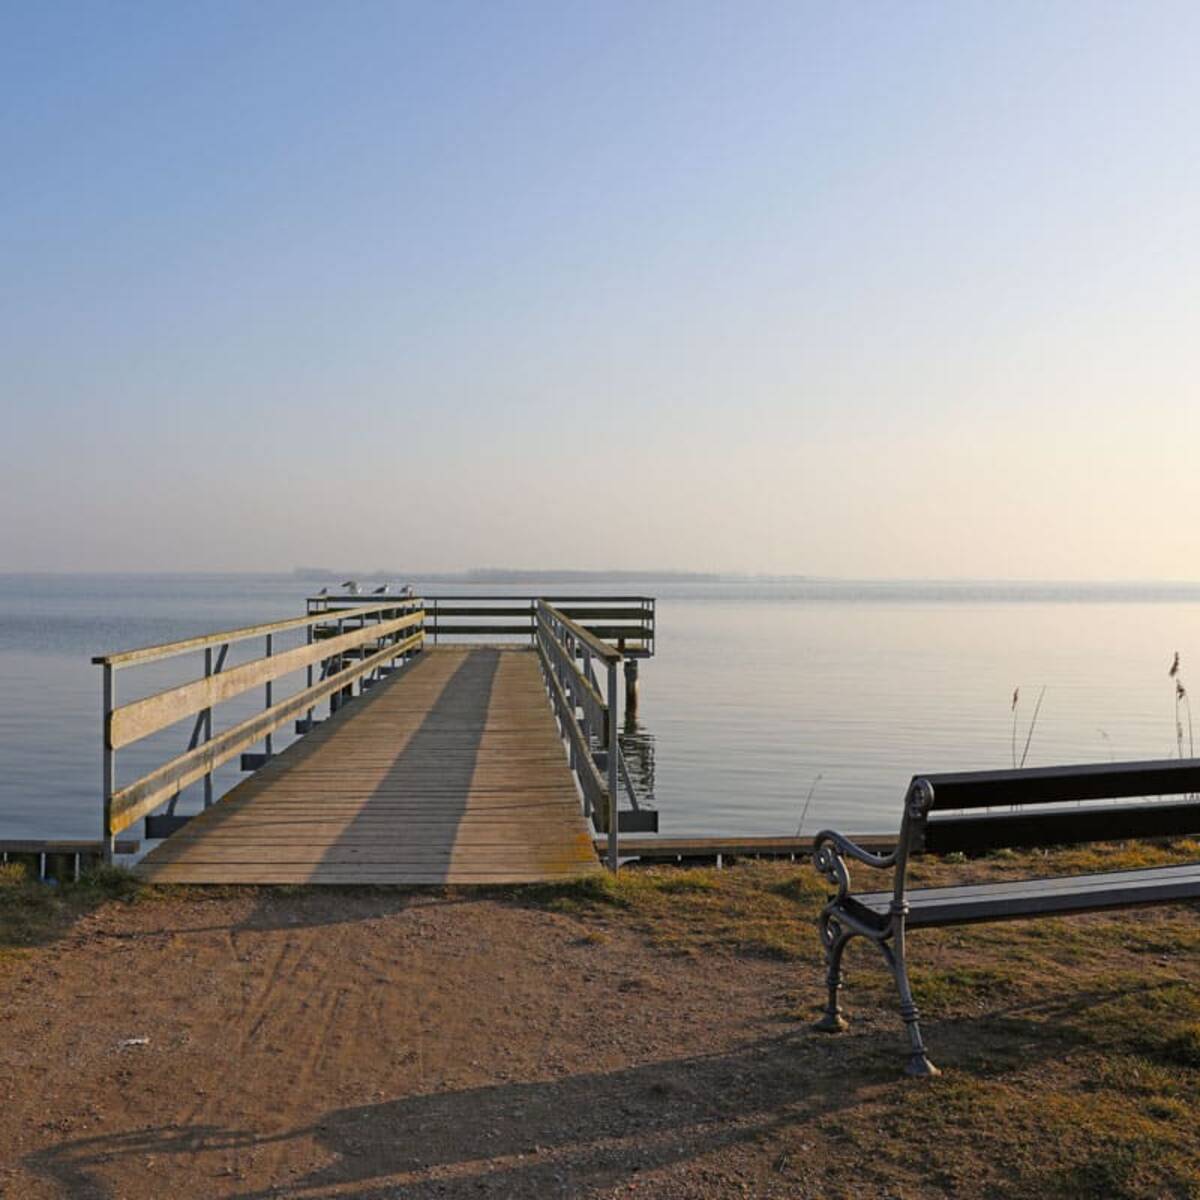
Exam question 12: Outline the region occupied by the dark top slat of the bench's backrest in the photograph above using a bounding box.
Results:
[918,758,1200,810]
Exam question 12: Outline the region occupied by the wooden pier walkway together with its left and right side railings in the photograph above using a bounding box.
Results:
[96,599,653,884]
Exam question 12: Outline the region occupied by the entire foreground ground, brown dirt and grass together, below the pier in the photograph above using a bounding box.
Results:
[9,842,1200,1200]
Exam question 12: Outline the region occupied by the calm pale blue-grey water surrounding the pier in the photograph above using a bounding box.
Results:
[0,576,1200,838]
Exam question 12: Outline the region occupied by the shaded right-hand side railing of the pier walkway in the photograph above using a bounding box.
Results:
[534,600,653,870]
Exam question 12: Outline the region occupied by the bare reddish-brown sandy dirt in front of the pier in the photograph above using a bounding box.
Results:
[0,890,883,1200]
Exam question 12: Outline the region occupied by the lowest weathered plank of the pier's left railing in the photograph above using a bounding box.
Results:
[109,634,422,833]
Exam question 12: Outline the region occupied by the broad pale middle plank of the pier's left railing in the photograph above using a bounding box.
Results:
[106,612,424,750]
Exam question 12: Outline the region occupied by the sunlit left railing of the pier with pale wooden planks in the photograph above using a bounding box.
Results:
[92,596,425,862]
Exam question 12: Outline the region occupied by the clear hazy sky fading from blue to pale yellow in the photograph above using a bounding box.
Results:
[0,0,1200,578]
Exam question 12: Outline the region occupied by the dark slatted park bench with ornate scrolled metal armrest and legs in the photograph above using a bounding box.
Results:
[814,758,1200,1075]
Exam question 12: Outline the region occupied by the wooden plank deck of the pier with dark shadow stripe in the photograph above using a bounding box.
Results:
[139,647,599,884]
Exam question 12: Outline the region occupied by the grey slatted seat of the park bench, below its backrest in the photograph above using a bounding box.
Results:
[844,863,1200,929]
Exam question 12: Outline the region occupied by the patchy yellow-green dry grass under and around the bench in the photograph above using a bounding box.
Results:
[518,840,1200,1200]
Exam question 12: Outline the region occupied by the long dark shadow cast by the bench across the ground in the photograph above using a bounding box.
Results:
[24,992,1123,1200]
